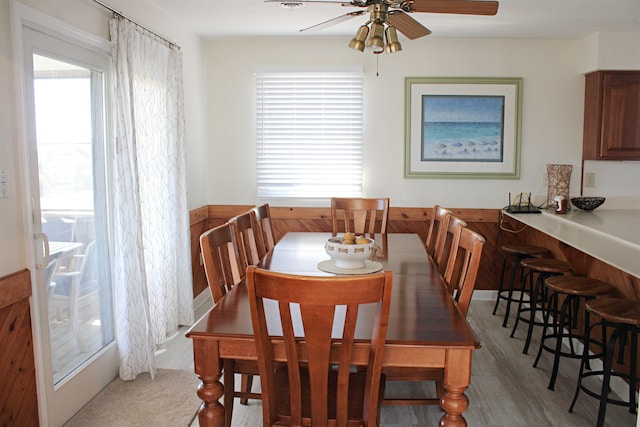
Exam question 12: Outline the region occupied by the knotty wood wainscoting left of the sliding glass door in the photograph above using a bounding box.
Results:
[0,269,39,426]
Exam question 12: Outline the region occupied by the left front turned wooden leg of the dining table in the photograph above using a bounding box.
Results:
[193,339,225,427]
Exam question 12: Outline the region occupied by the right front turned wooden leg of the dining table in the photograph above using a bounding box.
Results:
[440,350,471,427]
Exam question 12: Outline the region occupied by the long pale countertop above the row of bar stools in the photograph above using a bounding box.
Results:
[504,209,640,278]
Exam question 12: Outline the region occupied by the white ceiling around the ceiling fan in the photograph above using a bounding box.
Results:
[145,0,640,38]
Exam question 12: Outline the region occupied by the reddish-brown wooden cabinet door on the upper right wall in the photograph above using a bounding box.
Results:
[600,72,640,160]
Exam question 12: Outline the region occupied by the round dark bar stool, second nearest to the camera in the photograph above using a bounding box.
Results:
[533,276,611,390]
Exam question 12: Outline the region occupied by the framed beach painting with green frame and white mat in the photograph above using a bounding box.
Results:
[405,77,522,179]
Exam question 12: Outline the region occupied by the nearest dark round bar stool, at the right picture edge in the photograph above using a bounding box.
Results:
[569,297,640,427]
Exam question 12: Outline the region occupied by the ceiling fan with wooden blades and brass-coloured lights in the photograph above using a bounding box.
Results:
[265,0,498,53]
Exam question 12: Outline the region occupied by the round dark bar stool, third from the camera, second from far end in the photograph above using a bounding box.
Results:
[511,258,572,354]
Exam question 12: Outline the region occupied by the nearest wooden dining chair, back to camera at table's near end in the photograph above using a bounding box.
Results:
[247,266,392,426]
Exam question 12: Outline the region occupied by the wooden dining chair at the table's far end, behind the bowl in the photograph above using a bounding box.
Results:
[331,197,389,236]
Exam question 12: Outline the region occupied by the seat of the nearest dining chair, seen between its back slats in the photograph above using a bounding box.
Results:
[274,364,385,426]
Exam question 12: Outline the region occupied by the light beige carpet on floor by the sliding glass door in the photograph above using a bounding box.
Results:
[65,369,202,427]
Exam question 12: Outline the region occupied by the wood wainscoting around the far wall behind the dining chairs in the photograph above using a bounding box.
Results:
[191,205,502,296]
